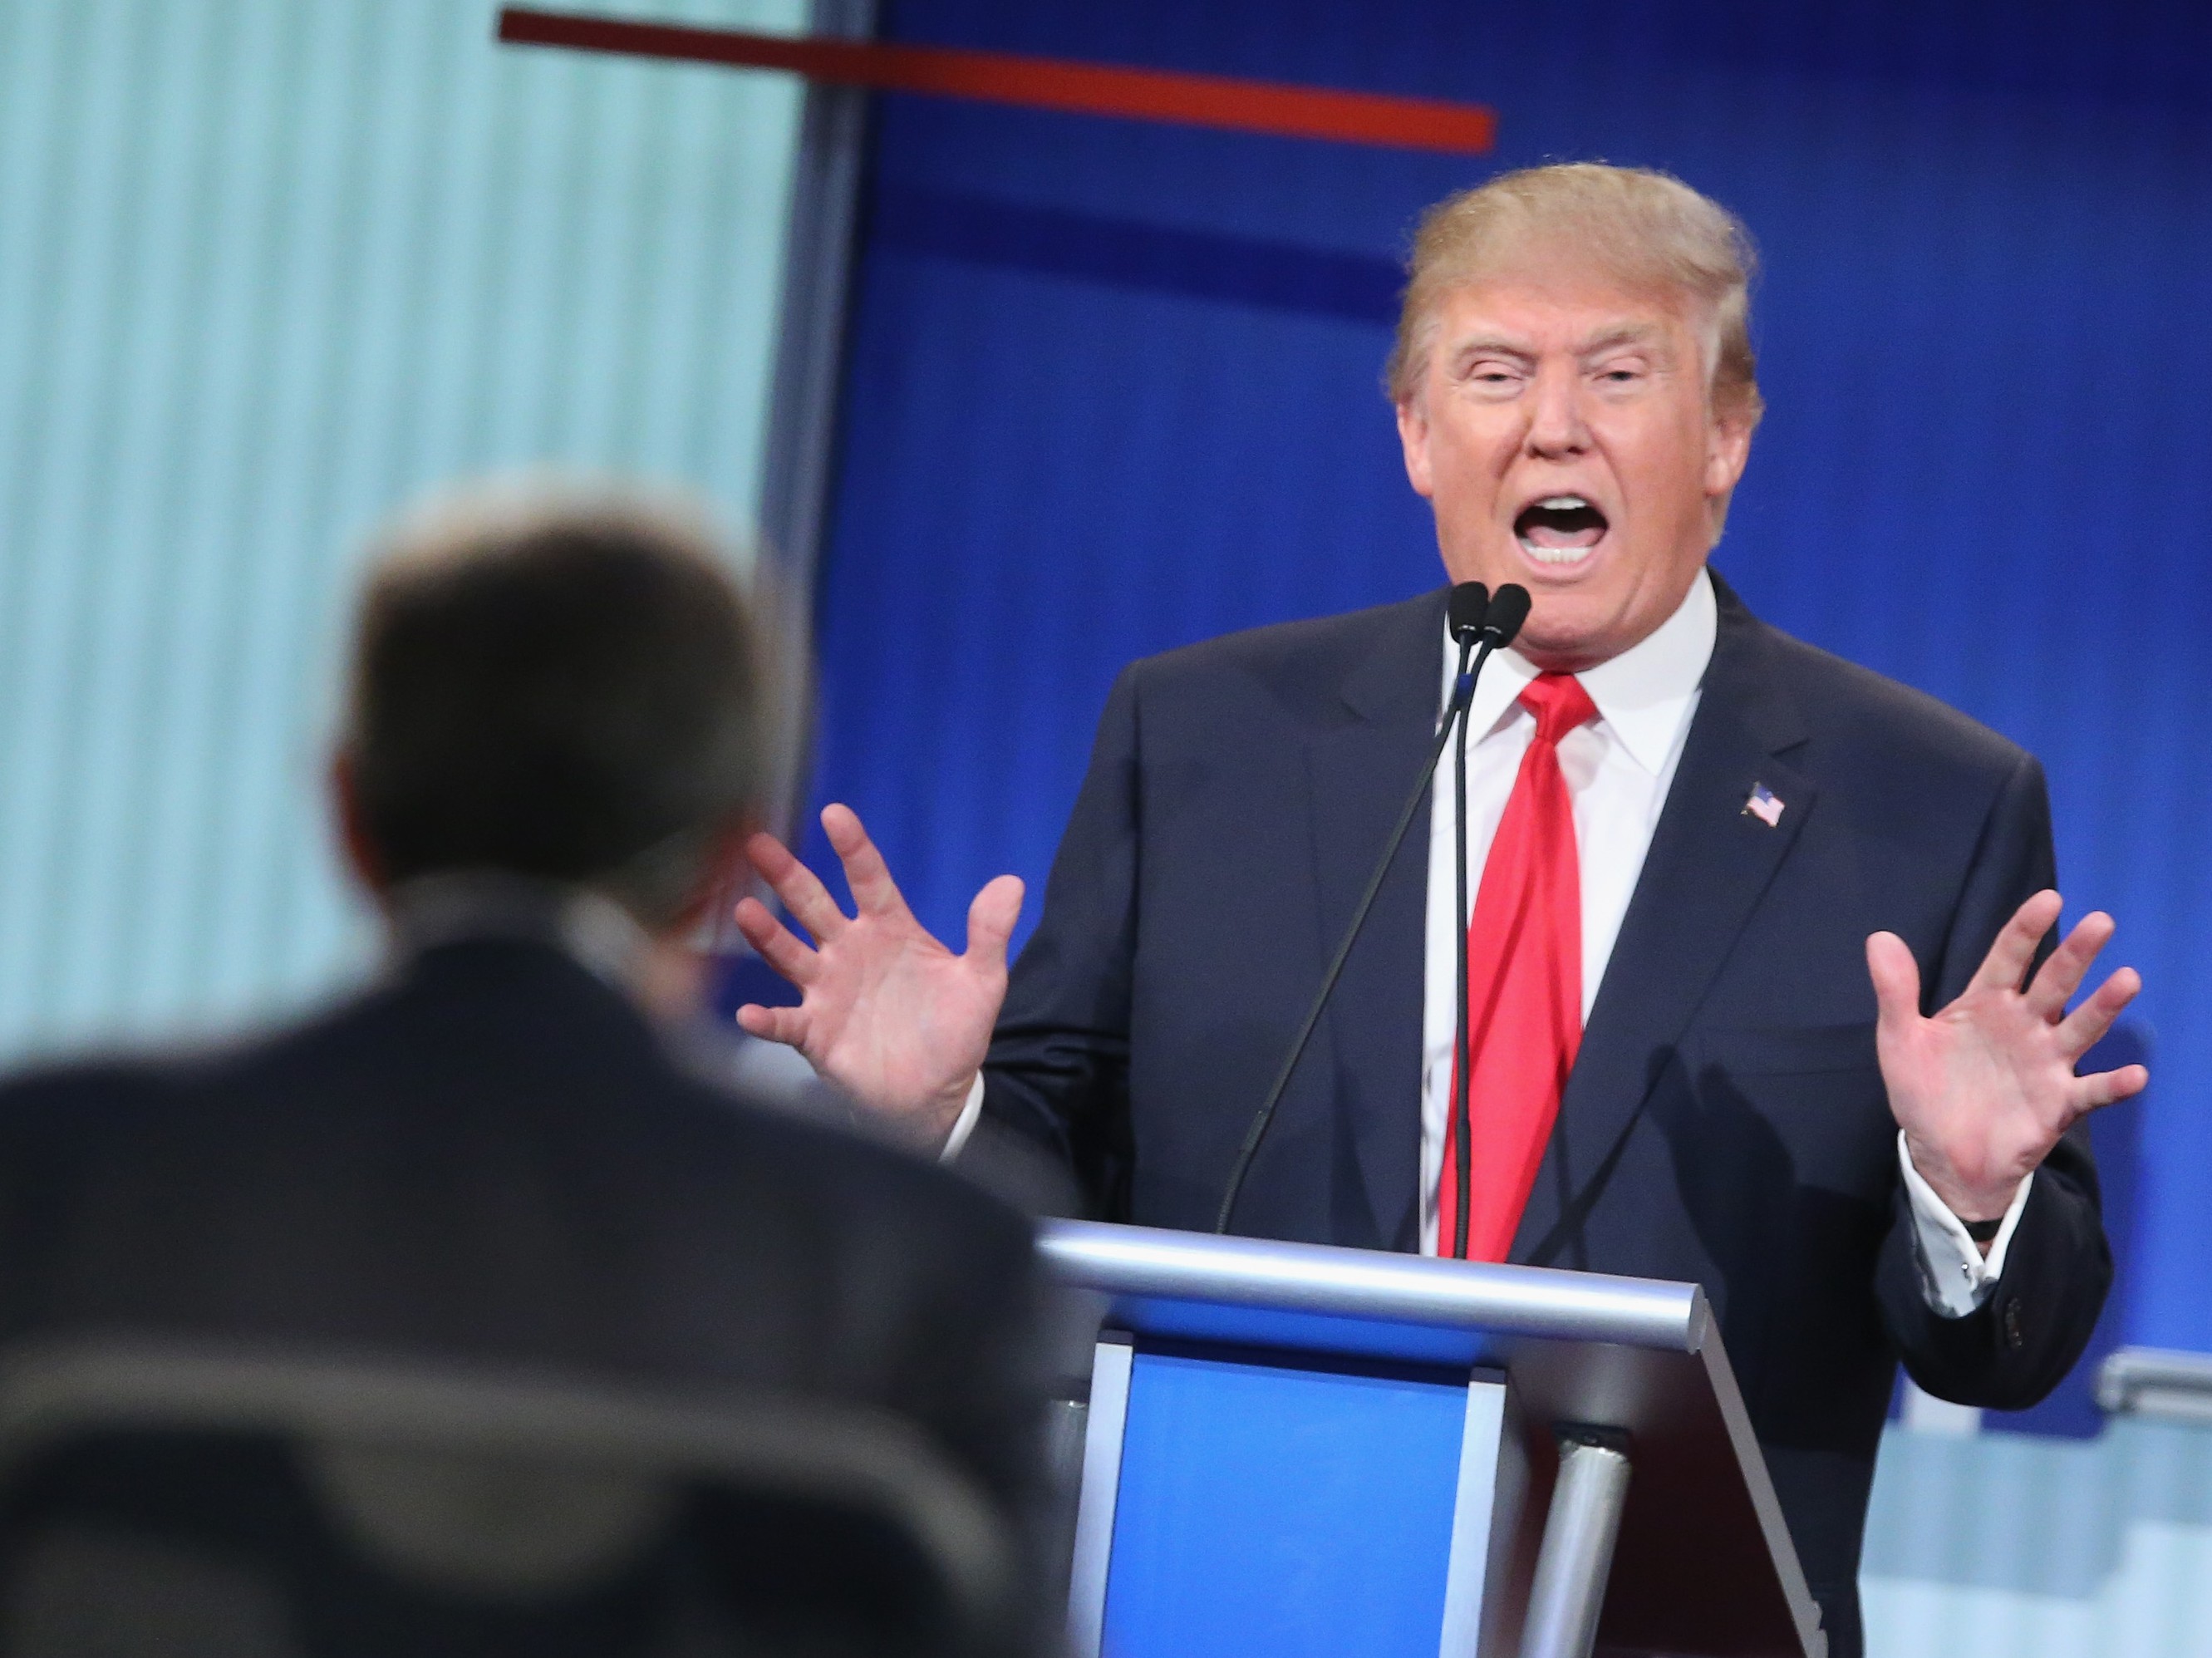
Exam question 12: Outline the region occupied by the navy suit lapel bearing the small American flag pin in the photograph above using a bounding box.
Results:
[1513,578,1816,1267]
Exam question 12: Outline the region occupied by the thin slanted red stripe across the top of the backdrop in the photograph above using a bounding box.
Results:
[500,7,1497,153]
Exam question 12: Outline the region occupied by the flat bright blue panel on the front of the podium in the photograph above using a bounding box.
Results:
[1104,1346,1467,1658]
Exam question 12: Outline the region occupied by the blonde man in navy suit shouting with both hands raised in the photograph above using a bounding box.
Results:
[739,166,2148,1654]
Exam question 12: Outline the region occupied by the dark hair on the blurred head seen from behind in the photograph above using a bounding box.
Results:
[343,487,768,927]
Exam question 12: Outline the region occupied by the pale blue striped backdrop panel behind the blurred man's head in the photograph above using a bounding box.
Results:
[0,0,805,1058]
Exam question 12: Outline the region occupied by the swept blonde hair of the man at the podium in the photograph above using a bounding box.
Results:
[1384,161,1765,427]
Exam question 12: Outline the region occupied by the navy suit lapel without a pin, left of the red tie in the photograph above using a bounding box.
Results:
[1305,591,1444,1248]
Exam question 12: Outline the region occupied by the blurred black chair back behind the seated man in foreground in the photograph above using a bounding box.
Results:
[0,1344,1022,1658]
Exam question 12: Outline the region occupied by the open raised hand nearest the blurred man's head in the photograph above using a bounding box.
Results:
[736,806,1022,1149]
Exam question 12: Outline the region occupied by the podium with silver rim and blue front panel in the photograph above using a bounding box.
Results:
[1040,1222,1827,1658]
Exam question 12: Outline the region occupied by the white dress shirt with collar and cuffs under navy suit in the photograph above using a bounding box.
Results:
[942,571,2033,1317]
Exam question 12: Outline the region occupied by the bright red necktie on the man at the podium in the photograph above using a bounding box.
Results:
[1436,673,1597,1262]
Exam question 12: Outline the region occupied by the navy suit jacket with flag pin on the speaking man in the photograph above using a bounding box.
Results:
[985,580,2111,1658]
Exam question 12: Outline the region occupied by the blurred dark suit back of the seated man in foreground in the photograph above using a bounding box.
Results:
[0,941,1035,1501]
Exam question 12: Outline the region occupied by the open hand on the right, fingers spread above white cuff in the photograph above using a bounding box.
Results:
[1867,890,2150,1220]
